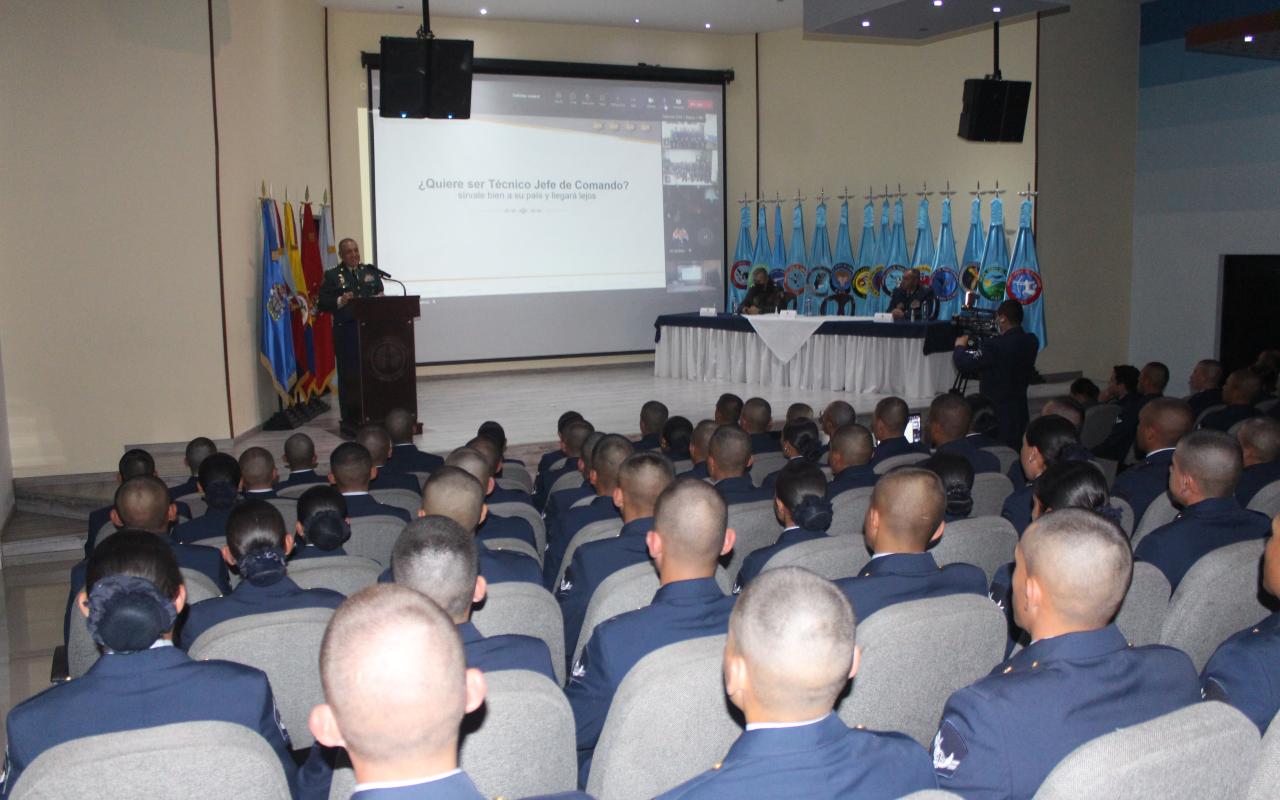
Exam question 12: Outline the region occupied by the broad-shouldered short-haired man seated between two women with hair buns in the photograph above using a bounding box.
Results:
[836,467,987,620]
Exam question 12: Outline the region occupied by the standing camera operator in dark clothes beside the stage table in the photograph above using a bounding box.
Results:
[951,300,1039,451]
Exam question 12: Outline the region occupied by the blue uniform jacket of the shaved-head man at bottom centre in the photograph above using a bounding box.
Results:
[658,714,937,800]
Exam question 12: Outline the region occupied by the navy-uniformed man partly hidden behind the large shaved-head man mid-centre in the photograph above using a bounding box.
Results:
[556,453,676,667]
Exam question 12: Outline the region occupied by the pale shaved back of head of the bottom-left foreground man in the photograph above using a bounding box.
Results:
[320,584,466,763]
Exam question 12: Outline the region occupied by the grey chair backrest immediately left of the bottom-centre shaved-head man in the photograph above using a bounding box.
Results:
[586,636,741,800]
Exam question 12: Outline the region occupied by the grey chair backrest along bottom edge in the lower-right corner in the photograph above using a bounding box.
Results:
[1036,703,1259,800]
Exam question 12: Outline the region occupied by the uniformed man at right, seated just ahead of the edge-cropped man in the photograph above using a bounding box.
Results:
[1134,430,1270,590]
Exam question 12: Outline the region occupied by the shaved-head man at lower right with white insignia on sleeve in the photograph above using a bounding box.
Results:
[933,508,1201,800]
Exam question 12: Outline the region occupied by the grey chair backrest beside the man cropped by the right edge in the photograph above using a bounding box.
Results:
[1160,539,1271,672]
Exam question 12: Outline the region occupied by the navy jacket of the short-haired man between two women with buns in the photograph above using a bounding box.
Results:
[836,552,987,621]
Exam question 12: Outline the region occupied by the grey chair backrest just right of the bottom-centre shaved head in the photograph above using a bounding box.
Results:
[836,594,1007,748]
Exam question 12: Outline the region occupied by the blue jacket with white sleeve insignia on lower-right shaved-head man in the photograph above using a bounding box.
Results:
[933,625,1201,800]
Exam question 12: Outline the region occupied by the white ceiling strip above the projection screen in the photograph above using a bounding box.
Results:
[320,0,804,33]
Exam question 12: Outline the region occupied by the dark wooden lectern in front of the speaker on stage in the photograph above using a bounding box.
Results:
[333,294,422,435]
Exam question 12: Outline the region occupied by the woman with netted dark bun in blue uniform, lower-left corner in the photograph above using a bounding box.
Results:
[3,530,296,796]
